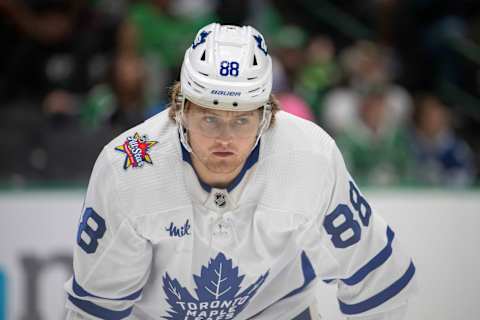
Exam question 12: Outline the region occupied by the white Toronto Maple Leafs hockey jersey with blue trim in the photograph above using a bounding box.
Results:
[65,111,415,320]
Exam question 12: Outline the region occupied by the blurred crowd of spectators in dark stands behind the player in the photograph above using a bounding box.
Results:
[0,0,480,188]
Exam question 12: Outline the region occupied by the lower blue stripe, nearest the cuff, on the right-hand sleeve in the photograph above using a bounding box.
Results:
[338,262,415,314]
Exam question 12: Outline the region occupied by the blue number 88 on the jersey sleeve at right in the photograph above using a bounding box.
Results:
[323,181,372,248]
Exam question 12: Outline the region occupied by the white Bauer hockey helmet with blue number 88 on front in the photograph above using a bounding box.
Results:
[180,23,272,111]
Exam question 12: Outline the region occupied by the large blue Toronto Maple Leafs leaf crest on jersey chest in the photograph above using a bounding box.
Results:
[163,253,268,320]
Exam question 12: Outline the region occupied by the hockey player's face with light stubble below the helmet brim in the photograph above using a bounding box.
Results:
[184,102,261,184]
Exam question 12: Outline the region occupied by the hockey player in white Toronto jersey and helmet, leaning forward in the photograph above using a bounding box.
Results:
[65,24,415,320]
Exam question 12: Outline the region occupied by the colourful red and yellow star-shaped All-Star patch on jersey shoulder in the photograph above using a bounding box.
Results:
[115,133,158,170]
